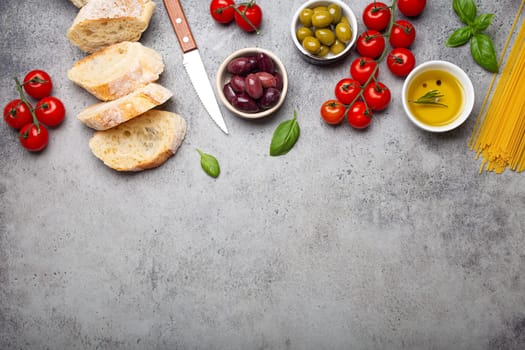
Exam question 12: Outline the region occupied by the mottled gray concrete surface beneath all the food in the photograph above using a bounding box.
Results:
[0,0,525,350]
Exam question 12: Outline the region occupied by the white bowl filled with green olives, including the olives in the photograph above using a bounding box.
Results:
[291,0,357,65]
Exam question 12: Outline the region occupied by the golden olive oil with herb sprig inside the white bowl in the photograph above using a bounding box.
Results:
[406,70,465,126]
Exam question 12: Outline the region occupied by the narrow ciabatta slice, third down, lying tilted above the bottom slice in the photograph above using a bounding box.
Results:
[77,83,173,130]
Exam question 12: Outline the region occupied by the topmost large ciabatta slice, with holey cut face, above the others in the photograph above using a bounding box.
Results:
[67,0,155,53]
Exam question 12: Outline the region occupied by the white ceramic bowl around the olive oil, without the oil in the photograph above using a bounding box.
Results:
[402,61,474,132]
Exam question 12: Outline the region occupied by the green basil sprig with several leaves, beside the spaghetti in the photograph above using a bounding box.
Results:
[446,0,499,73]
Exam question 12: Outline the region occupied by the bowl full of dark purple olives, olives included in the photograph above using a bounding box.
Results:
[216,47,288,119]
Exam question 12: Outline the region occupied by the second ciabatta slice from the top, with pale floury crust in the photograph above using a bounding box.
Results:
[67,41,164,101]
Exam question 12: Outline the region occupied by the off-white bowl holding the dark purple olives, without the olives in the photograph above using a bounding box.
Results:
[216,47,288,119]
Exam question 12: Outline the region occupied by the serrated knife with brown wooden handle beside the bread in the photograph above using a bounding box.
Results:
[164,0,228,134]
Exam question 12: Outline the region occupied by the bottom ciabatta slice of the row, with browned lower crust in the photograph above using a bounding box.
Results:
[89,109,186,171]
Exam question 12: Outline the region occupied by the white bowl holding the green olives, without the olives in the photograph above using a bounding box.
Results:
[290,0,358,65]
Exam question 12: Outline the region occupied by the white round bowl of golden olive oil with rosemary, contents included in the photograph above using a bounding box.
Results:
[402,61,474,132]
